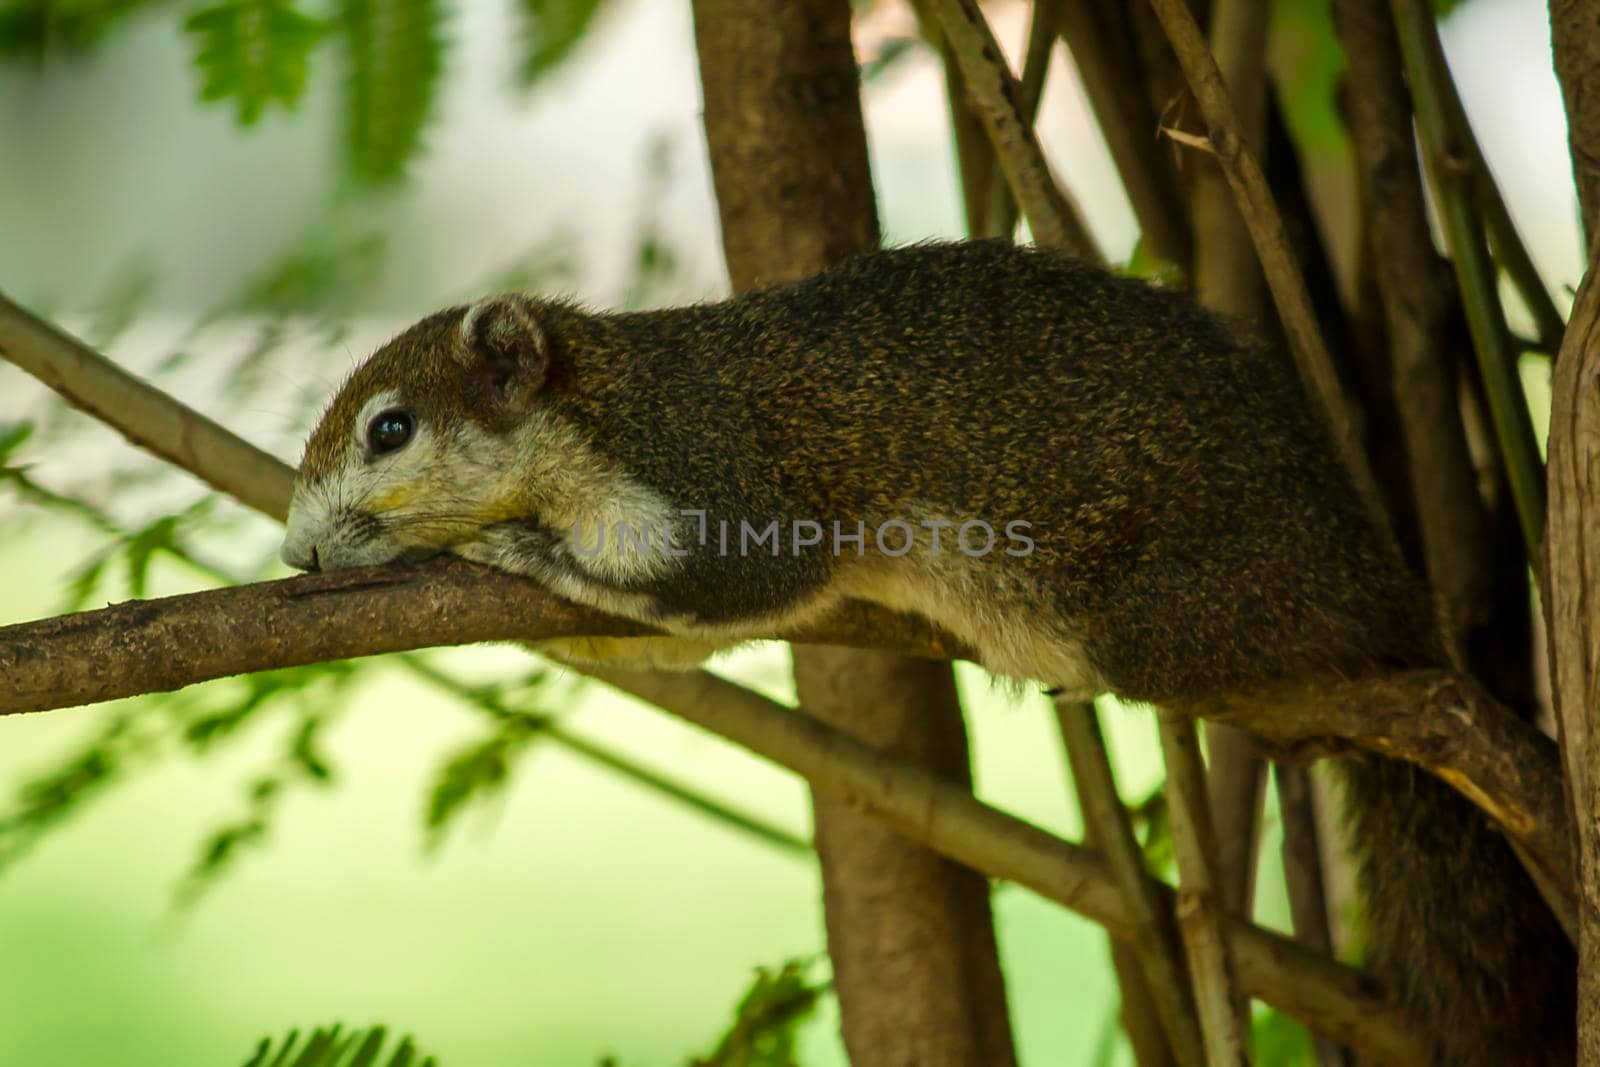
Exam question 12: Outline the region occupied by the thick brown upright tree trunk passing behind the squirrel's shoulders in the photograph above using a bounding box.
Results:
[694,0,1014,1067]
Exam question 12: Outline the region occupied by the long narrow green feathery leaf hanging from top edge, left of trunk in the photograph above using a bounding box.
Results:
[339,0,445,182]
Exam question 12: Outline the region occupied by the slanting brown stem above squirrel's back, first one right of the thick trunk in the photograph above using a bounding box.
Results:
[931,0,1104,262]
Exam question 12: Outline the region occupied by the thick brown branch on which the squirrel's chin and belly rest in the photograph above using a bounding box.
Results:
[0,558,962,715]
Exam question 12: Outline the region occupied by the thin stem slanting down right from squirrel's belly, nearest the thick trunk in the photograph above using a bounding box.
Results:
[1056,699,1205,1067]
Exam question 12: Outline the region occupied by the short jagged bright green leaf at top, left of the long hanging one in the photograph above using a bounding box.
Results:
[184,0,328,126]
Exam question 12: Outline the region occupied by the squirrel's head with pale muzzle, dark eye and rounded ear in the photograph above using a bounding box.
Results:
[282,294,550,571]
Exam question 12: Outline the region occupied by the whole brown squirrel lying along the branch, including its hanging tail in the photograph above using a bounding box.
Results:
[282,242,1576,1067]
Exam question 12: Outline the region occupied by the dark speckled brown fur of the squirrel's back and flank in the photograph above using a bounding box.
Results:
[552,242,1437,701]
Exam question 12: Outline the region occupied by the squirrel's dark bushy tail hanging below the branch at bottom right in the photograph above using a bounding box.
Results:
[1339,755,1576,1067]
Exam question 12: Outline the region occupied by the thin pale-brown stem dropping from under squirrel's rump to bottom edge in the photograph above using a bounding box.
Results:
[1158,710,1250,1067]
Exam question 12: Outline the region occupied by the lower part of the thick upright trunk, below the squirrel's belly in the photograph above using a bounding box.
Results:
[795,646,1014,1067]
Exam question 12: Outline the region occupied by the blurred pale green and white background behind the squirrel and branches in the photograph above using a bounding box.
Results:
[0,0,1581,1067]
